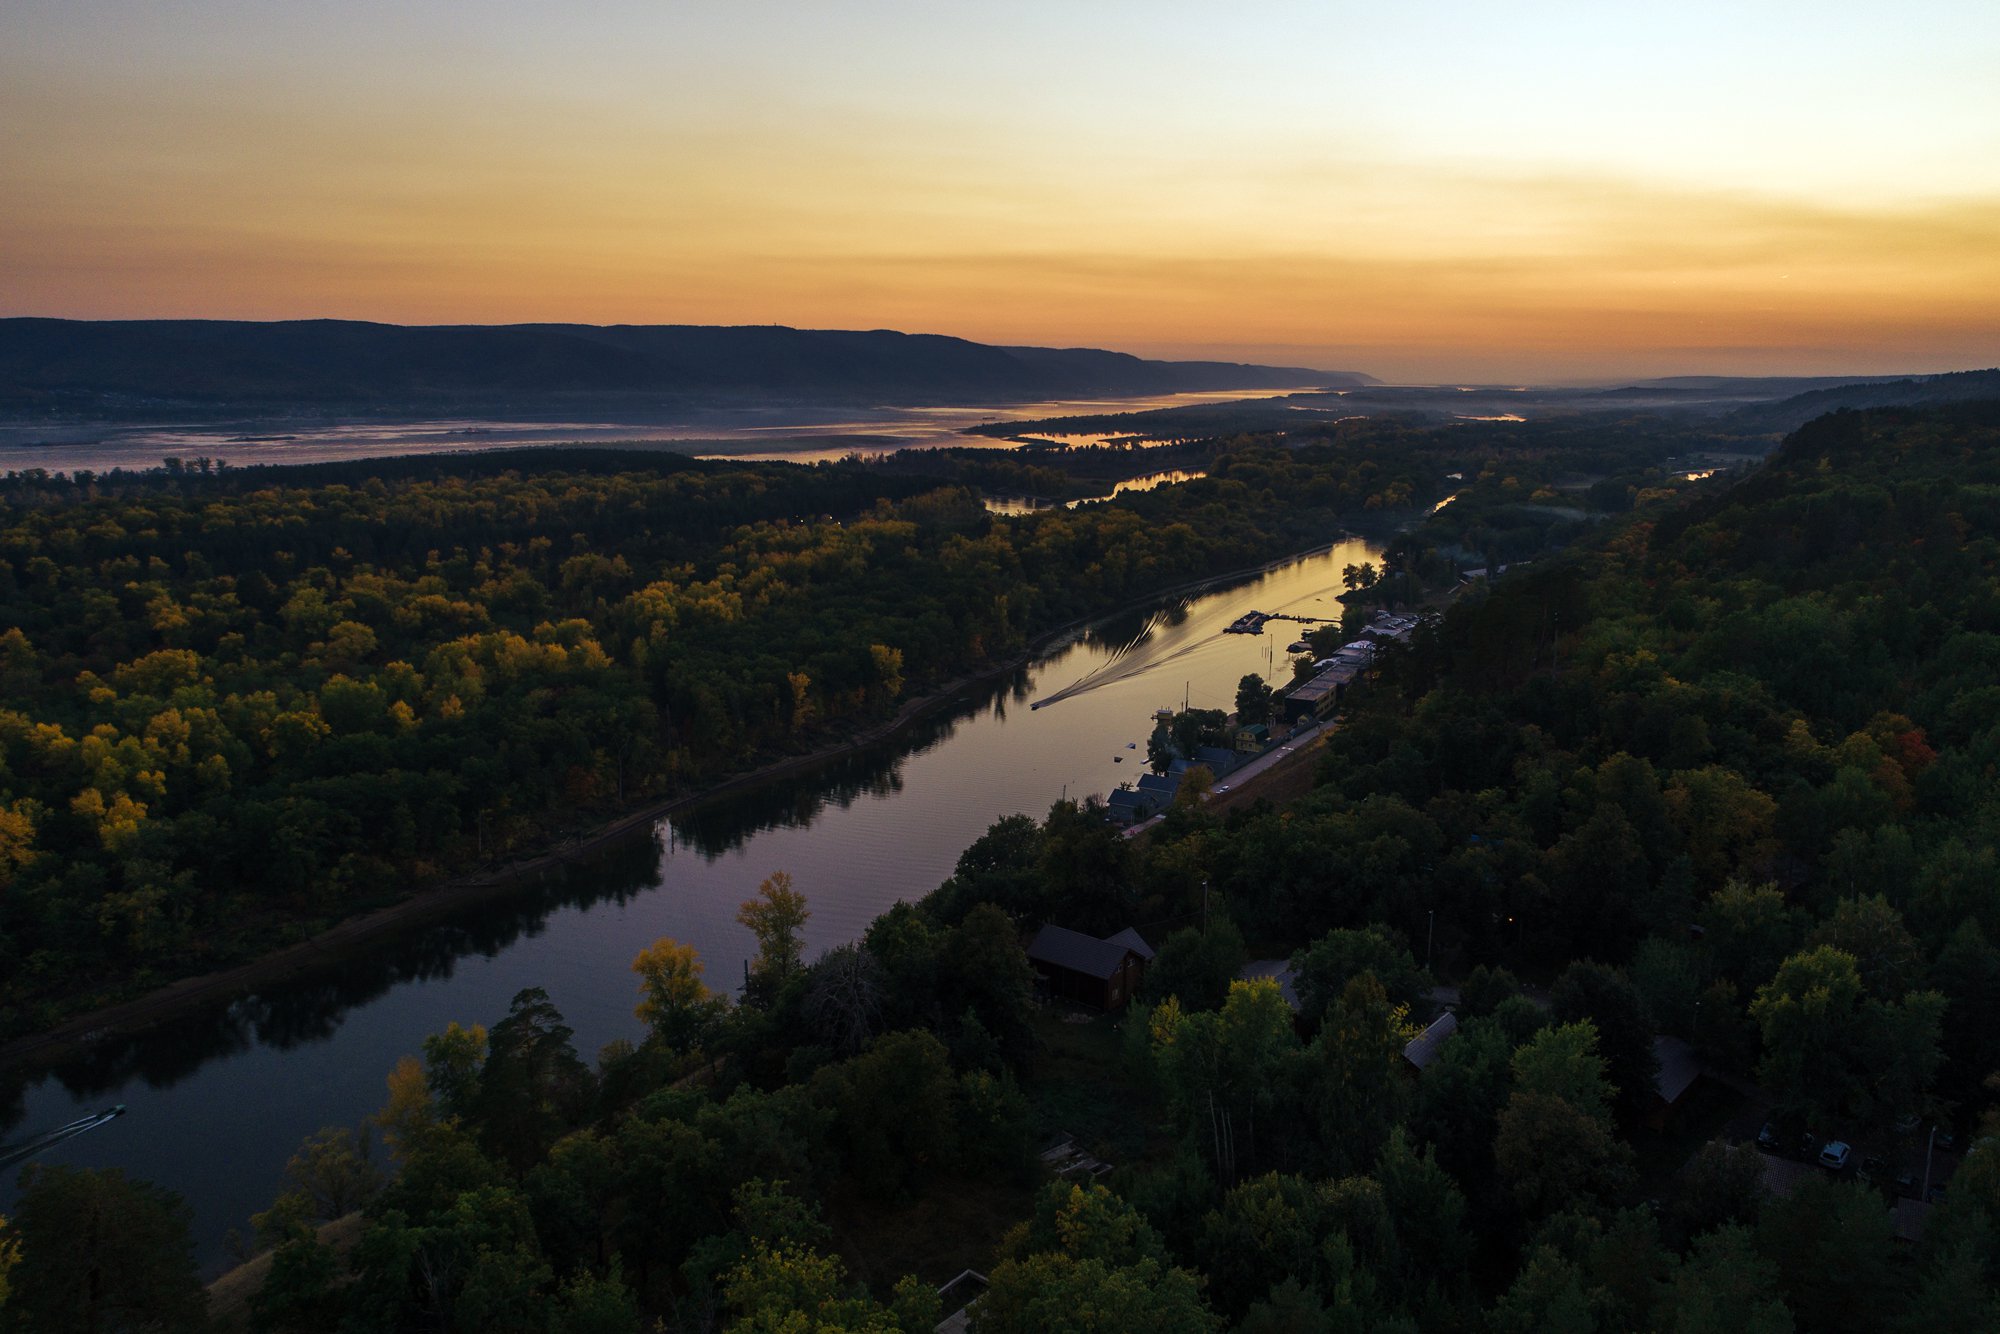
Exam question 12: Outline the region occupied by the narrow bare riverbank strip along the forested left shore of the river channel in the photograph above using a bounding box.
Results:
[0,544,1360,1068]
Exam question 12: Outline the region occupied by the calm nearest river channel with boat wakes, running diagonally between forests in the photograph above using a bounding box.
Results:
[0,540,1382,1272]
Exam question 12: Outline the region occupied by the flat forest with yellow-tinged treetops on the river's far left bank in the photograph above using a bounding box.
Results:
[0,448,1434,1032]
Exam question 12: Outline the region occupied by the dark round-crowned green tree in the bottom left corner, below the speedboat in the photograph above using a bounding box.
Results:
[6,1166,208,1334]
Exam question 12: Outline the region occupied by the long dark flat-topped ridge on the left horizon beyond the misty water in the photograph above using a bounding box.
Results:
[0,318,1374,414]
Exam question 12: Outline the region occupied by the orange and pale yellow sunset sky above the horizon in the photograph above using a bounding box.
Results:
[0,0,2000,382]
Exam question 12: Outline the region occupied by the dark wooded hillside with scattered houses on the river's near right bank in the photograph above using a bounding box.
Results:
[12,406,2000,1334]
